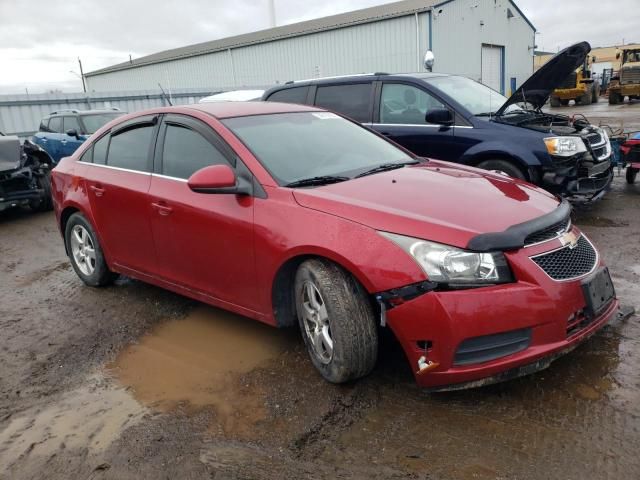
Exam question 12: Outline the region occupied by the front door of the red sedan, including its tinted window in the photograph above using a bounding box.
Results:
[150,115,257,310]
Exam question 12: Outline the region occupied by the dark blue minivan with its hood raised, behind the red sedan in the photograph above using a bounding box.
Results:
[263,42,613,200]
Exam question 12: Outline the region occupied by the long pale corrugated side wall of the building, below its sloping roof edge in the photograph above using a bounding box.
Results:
[87,13,429,91]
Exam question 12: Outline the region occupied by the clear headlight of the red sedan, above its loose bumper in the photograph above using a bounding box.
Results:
[379,232,513,286]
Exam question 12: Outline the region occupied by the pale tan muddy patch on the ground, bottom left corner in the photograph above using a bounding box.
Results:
[0,377,145,477]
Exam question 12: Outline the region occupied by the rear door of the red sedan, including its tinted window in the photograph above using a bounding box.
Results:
[85,116,159,274]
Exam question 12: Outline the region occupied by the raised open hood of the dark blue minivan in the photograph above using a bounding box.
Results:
[496,42,591,115]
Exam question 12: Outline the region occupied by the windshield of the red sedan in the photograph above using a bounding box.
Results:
[223,112,414,185]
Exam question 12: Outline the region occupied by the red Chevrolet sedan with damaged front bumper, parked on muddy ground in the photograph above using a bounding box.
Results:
[52,102,618,389]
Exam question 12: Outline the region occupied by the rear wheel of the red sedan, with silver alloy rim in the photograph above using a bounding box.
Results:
[64,213,117,287]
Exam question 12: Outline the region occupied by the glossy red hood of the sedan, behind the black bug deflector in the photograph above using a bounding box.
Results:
[293,161,559,248]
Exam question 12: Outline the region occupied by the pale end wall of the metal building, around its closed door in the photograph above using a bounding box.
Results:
[431,0,534,95]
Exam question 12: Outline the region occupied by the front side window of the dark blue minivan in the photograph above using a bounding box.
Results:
[380,83,446,125]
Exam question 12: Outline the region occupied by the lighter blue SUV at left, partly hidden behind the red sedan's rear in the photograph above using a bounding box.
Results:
[33,109,126,163]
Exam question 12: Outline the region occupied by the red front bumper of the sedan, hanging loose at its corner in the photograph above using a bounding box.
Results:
[386,236,618,390]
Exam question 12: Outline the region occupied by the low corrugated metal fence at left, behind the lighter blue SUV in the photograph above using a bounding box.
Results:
[0,89,213,137]
